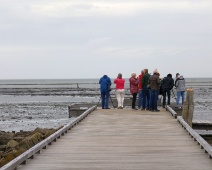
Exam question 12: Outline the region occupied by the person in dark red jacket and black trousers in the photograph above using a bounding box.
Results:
[129,73,138,110]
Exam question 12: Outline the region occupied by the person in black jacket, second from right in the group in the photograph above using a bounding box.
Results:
[161,74,174,108]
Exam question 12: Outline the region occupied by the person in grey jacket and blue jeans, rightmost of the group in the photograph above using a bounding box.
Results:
[176,75,185,105]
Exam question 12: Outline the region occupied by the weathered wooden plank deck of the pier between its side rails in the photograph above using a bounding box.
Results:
[18,109,212,170]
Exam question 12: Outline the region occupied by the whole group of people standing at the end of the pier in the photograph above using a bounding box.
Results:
[99,69,185,112]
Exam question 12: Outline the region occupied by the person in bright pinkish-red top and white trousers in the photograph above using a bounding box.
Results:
[114,73,125,109]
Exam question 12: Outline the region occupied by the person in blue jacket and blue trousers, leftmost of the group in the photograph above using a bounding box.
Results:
[99,75,111,109]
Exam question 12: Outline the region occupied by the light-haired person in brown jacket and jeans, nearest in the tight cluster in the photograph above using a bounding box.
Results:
[149,69,160,112]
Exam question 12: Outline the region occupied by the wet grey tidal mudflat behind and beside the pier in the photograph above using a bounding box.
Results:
[0,86,212,132]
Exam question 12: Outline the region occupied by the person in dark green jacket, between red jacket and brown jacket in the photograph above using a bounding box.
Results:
[141,69,150,110]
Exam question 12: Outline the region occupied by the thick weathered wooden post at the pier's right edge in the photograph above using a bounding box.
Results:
[182,89,194,127]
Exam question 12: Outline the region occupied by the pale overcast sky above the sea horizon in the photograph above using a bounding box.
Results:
[0,0,212,79]
